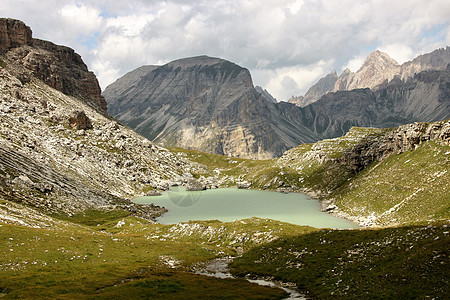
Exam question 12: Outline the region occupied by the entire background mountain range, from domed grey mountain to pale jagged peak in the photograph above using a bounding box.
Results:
[103,47,450,159]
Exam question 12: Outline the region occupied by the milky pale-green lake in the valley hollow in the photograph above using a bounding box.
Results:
[133,187,358,229]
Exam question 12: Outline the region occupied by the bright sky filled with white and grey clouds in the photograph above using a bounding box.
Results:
[0,0,450,100]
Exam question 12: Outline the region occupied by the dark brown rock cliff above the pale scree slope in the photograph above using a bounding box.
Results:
[0,19,106,111]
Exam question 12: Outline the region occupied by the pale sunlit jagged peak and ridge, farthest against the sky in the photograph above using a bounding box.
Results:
[289,46,450,107]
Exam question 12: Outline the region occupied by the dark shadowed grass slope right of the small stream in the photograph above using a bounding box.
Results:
[231,225,450,299]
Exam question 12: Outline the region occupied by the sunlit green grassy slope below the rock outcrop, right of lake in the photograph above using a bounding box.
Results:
[330,142,450,225]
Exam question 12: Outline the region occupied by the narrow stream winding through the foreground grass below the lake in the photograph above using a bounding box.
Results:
[194,257,307,299]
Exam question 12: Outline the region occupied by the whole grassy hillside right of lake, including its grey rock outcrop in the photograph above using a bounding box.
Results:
[277,121,450,226]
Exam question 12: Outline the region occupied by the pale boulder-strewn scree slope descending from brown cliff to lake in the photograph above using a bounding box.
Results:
[0,20,197,218]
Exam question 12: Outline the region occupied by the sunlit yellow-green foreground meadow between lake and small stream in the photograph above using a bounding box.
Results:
[0,206,316,299]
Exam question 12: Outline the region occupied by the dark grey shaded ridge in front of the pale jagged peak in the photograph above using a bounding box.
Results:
[279,66,450,138]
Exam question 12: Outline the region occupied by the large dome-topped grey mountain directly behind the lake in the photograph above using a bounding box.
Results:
[103,56,317,159]
